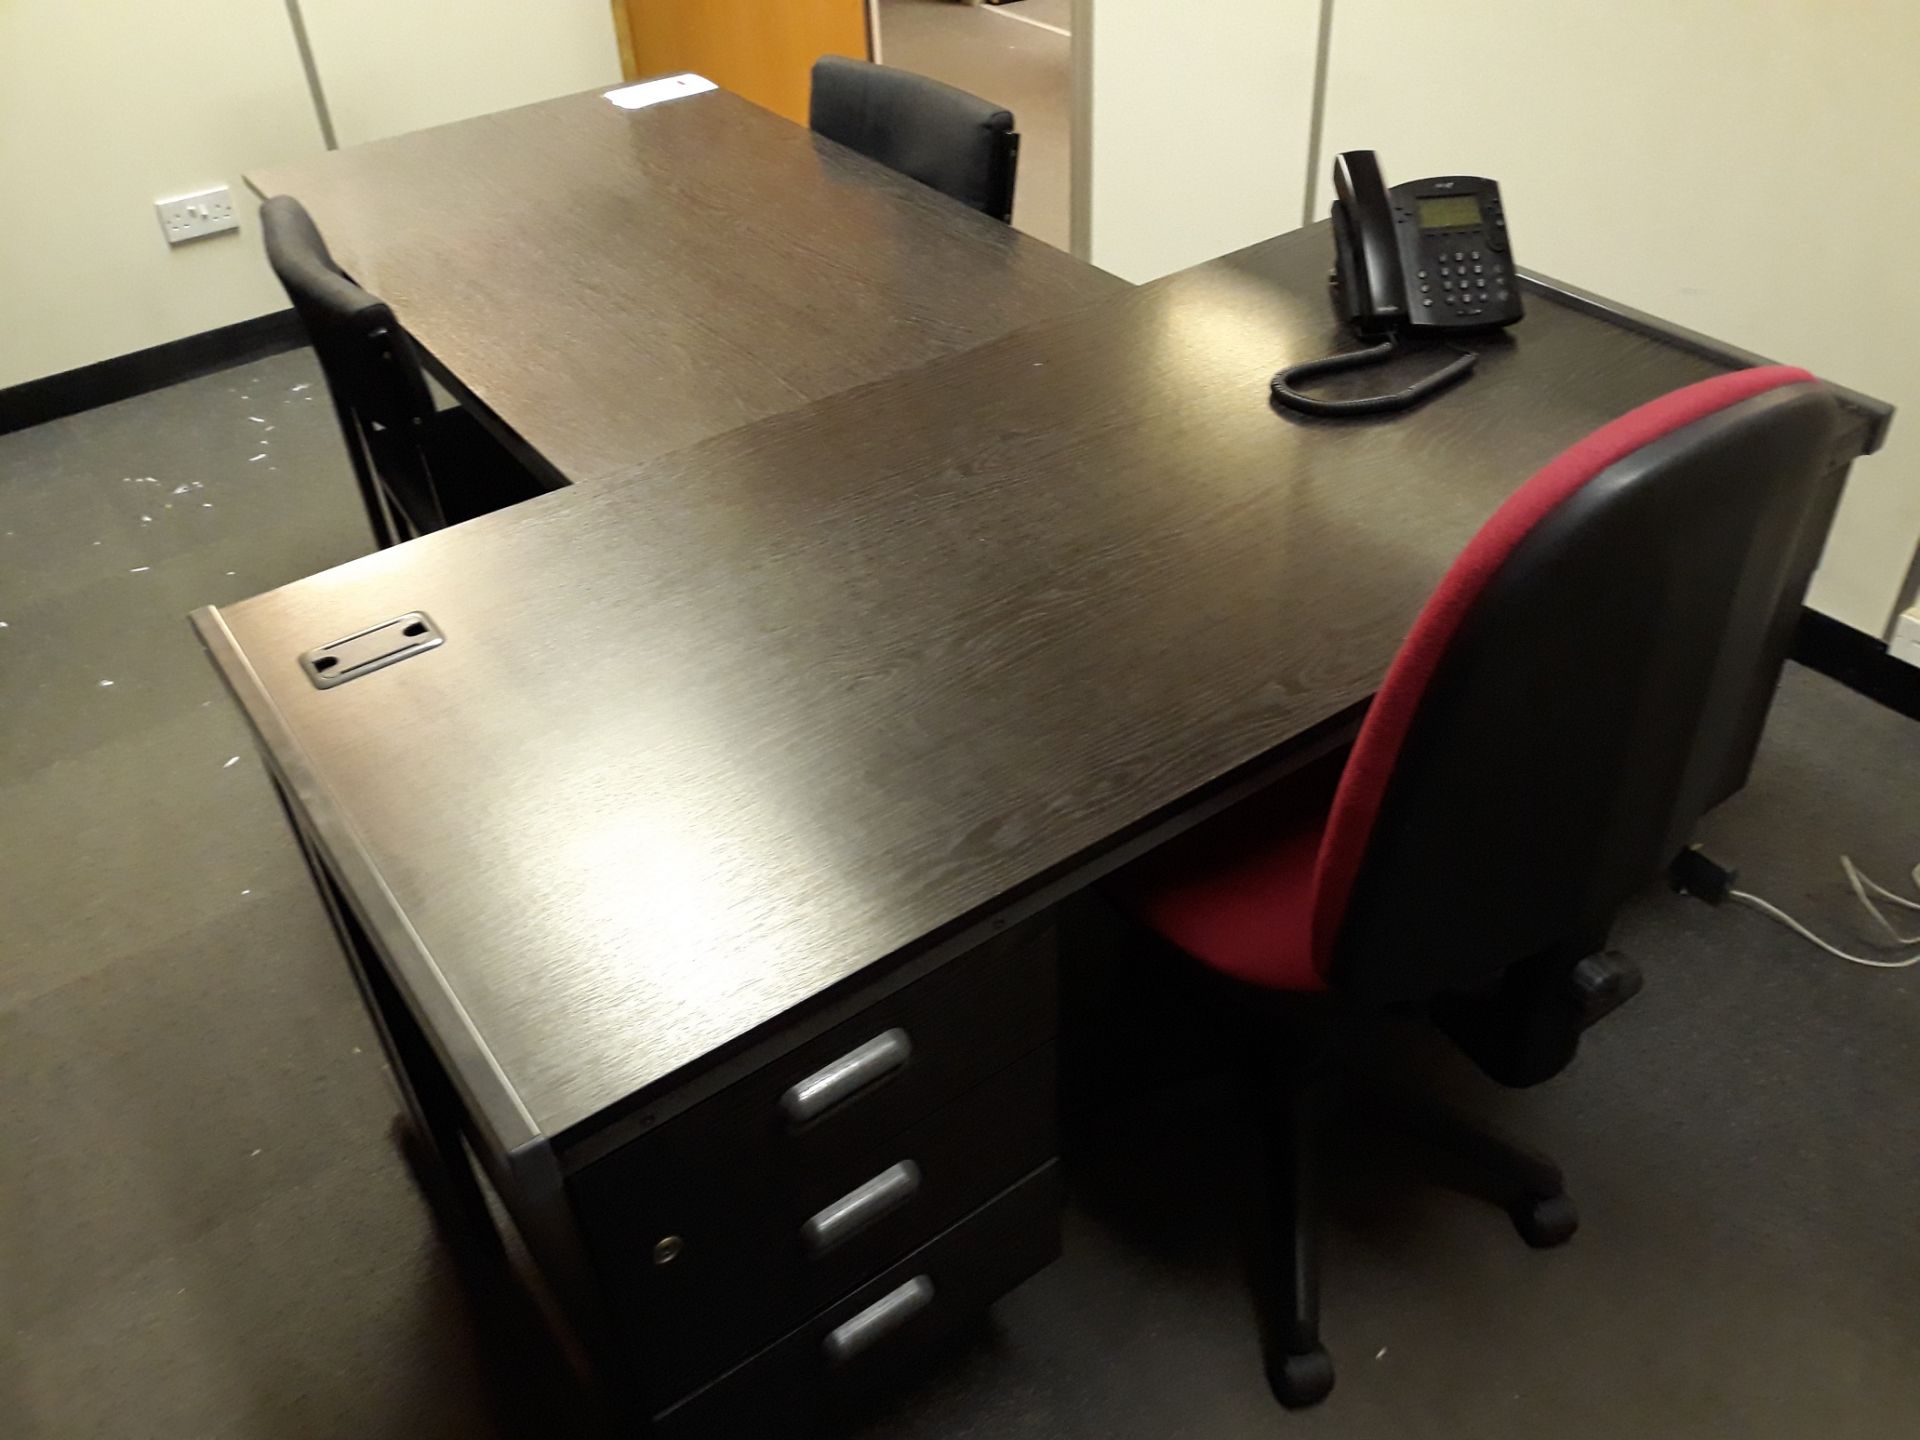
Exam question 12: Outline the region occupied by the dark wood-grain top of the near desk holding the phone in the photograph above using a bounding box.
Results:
[198,232,1743,1131]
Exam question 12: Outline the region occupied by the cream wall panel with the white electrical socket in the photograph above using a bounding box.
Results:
[0,0,321,386]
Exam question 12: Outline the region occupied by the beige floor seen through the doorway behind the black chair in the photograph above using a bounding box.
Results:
[879,0,1073,250]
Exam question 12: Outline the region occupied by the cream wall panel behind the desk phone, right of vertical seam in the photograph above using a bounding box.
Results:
[1320,0,1920,636]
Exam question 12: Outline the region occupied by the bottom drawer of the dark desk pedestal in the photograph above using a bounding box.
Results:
[655,1162,1060,1440]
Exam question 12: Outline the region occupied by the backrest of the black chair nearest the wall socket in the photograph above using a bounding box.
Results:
[259,196,442,530]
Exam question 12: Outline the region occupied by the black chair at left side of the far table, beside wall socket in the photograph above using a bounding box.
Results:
[259,196,543,549]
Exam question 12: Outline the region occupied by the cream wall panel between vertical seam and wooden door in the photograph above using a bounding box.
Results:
[300,0,620,146]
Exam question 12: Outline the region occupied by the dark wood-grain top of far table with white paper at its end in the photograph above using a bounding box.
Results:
[248,90,1127,482]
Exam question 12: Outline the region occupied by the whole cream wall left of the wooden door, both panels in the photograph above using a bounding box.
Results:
[0,0,620,395]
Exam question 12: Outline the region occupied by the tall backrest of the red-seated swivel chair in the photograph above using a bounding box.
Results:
[1315,367,1843,1002]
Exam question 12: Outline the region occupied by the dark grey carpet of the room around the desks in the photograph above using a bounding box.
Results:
[0,353,1920,1440]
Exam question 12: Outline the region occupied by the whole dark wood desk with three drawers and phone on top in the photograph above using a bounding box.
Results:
[196,222,1889,1434]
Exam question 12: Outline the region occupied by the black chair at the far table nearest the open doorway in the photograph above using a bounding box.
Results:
[808,56,1020,221]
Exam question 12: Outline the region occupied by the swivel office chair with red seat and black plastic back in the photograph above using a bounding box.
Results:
[1108,367,1841,1407]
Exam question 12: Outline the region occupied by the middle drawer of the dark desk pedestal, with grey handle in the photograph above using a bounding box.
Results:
[601,1044,1054,1402]
